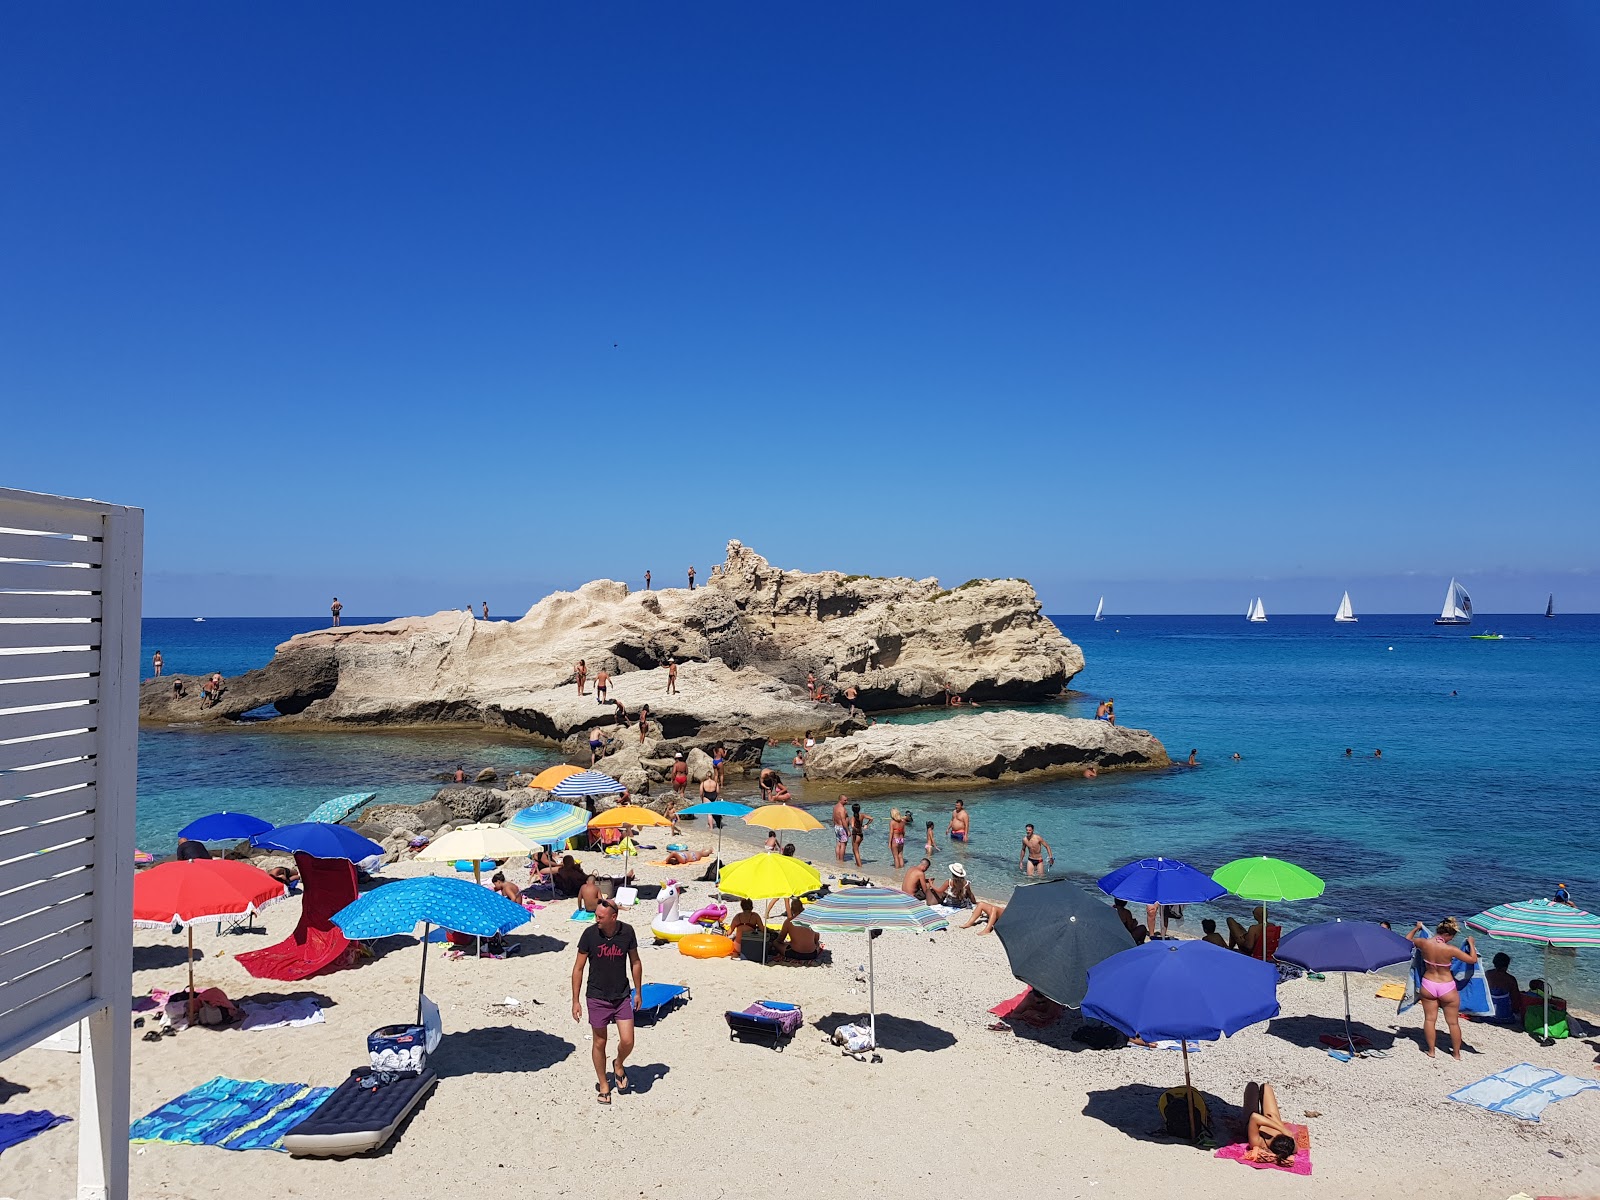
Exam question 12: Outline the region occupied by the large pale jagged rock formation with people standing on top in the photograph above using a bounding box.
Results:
[139,542,1083,744]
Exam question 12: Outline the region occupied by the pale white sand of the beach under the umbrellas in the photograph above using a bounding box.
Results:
[0,832,1600,1200]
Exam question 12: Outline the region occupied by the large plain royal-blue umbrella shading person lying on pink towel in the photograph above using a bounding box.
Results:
[1081,947,1278,1134]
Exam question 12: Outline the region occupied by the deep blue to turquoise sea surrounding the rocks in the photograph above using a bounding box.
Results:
[138,614,1600,1010]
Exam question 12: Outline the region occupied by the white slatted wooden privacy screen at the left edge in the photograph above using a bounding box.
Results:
[0,488,144,1200]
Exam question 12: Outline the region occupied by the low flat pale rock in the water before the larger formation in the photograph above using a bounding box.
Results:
[805,710,1170,784]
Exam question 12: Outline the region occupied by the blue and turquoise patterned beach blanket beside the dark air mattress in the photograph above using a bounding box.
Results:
[128,1075,333,1150]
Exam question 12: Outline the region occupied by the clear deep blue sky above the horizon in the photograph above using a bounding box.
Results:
[0,3,1600,614]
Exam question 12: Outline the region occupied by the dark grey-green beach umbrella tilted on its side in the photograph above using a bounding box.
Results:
[995,877,1139,1008]
